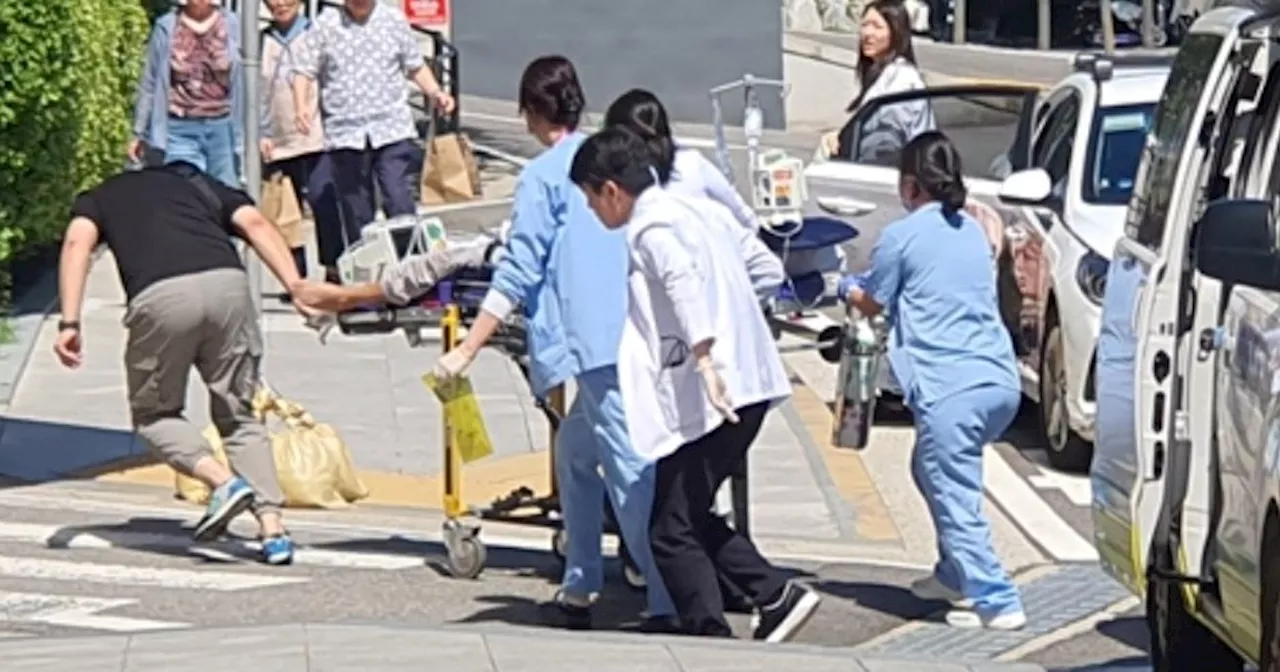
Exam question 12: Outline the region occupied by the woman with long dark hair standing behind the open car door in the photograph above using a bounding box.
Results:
[819,0,934,165]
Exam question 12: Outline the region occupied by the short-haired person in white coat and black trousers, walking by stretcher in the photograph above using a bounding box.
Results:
[570,127,818,641]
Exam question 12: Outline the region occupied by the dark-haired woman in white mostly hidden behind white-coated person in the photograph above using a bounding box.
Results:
[604,88,760,233]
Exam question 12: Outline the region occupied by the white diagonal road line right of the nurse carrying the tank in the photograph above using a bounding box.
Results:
[983,447,1098,562]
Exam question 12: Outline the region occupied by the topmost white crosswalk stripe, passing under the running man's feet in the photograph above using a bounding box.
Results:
[0,522,422,568]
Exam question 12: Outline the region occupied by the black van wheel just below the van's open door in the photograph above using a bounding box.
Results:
[1147,545,1244,672]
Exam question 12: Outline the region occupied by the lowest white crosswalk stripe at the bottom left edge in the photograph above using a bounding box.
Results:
[0,591,191,632]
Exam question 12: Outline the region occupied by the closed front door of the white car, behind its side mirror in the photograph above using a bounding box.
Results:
[1000,87,1083,371]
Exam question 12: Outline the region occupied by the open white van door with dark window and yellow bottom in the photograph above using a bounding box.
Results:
[1091,10,1252,594]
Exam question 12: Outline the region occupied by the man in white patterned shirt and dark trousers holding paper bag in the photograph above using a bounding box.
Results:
[293,0,454,244]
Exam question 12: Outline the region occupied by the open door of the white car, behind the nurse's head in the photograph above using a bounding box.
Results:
[805,84,1039,270]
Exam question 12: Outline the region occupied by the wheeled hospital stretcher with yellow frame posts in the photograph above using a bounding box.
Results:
[337,269,748,589]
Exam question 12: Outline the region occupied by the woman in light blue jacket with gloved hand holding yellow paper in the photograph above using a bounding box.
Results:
[435,56,677,631]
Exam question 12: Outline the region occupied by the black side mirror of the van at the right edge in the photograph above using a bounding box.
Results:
[1192,198,1280,291]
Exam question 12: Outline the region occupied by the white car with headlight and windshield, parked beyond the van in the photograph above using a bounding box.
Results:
[1000,54,1169,471]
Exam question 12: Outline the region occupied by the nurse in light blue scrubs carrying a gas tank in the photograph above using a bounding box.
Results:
[842,131,1027,630]
